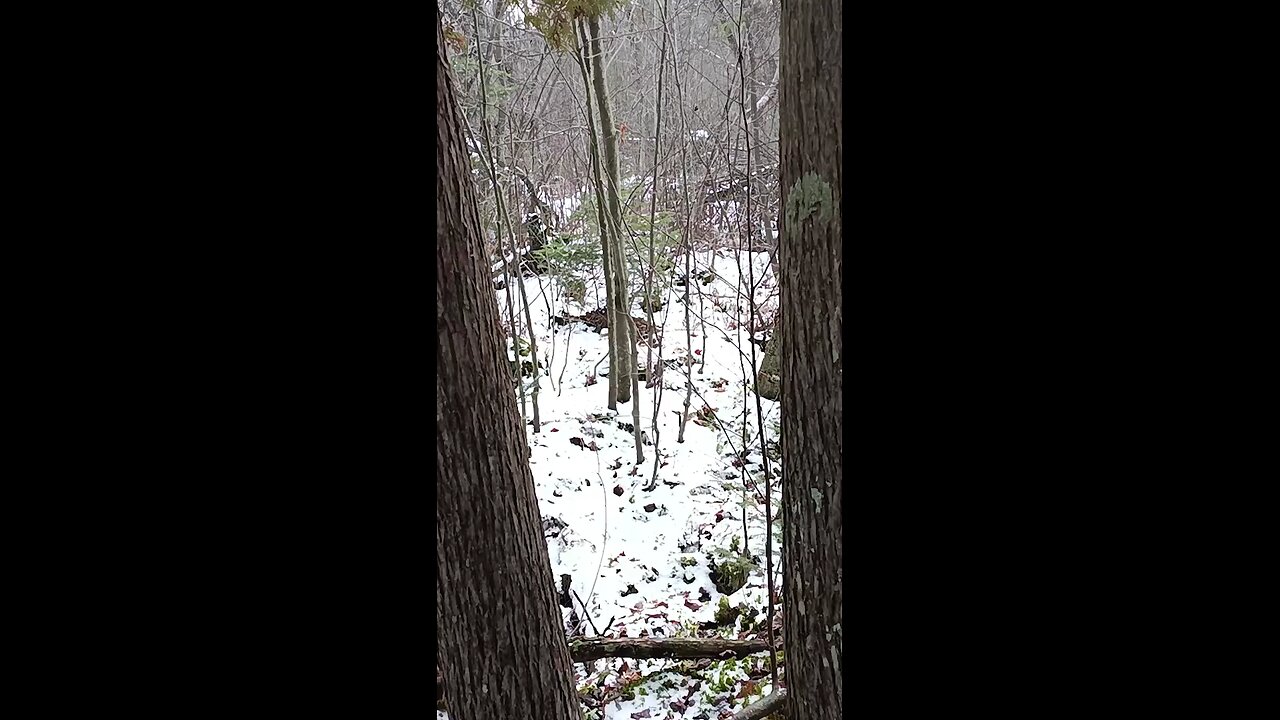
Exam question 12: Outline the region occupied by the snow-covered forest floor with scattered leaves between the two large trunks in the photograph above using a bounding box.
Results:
[438,243,782,720]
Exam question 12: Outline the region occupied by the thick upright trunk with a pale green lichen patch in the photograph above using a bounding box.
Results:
[778,0,844,720]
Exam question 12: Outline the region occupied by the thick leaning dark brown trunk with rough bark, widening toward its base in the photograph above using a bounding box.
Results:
[435,17,581,720]
